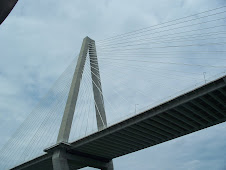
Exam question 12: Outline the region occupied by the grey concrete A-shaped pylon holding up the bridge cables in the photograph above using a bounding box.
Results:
[52,37,113,170]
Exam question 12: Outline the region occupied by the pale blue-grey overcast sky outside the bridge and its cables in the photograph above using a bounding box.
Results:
[0,0,226,170]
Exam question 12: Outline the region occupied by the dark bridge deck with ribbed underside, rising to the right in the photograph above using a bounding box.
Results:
[11,77,226,169]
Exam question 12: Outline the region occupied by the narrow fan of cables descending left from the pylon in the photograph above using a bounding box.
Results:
[0,58,77,169]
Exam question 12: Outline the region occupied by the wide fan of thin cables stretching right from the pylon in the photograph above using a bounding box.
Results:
[93,6,226,124]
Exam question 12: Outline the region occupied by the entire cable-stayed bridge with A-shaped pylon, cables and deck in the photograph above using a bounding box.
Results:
[0,4,226,170]
